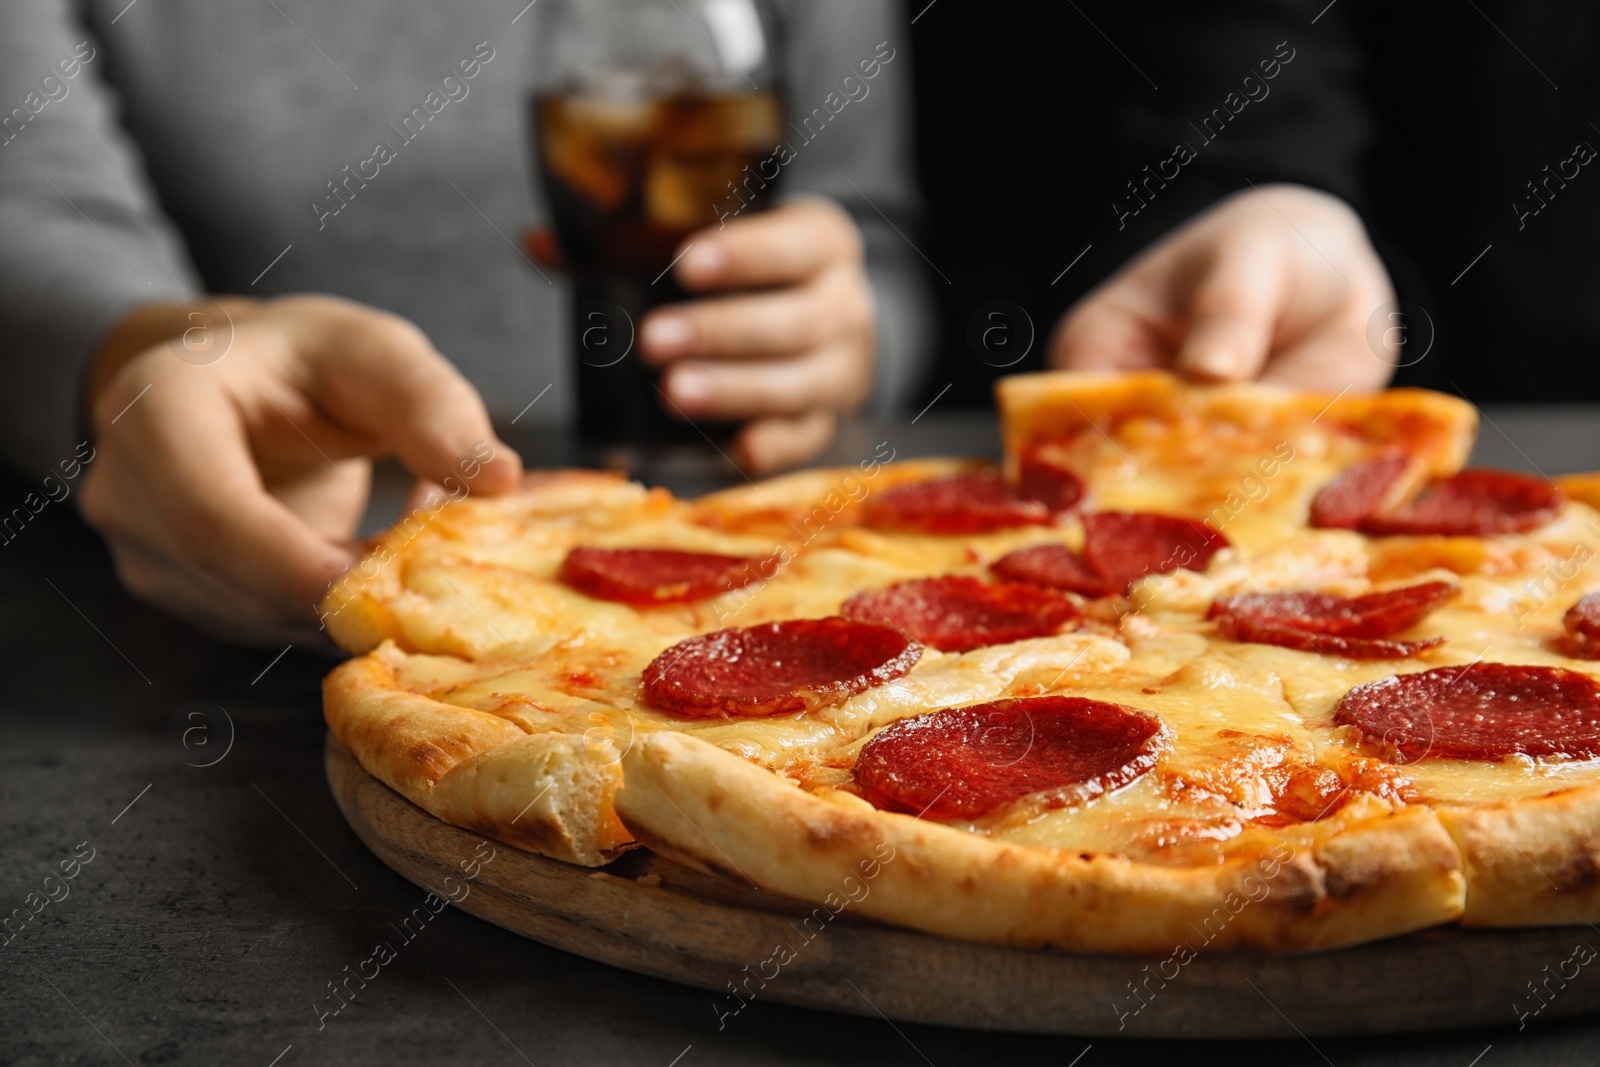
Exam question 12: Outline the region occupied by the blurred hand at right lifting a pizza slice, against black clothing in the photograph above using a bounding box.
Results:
[1050,186,1400,392]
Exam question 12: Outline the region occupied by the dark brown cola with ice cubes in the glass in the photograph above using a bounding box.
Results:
[530,90,782,446]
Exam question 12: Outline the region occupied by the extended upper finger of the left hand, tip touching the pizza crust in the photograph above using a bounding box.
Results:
[291,309,522,494]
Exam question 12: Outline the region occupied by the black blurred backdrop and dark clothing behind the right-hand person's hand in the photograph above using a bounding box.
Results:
[907,0,1600,408]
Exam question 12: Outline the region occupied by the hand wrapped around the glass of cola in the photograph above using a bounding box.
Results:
[640,198,875,472]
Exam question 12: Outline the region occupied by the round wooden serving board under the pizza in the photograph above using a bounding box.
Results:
[326,736,1600,1038]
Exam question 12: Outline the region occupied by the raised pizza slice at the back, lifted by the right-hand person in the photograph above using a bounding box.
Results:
[995,371,1477,547]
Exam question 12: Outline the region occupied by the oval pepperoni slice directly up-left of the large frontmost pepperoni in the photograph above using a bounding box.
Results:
[645,616,922,717]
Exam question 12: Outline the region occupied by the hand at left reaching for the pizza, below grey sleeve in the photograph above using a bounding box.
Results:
[82,296,522,640]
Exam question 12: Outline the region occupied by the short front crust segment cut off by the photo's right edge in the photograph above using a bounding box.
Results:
[1438,785,1600,926]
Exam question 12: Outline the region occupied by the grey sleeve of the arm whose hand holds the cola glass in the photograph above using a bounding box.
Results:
[768,0,933,411]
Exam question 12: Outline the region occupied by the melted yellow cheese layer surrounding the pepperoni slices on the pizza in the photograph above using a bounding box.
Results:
[344,399,1600,862]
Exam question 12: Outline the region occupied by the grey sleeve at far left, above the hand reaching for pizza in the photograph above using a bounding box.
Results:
[0,0,200,477]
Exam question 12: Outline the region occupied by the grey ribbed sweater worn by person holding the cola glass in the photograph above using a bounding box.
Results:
[0,0,928,475]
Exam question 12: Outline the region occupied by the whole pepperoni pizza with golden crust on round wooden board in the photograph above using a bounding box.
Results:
[325,373,1600,952]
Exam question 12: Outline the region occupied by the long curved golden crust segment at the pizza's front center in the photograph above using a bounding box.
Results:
[618,733,1462,953]
